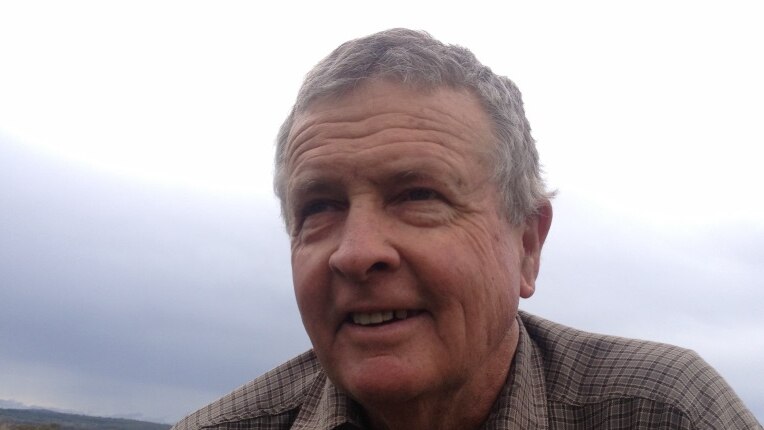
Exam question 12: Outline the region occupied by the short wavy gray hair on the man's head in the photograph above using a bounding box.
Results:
[274,28,553,228]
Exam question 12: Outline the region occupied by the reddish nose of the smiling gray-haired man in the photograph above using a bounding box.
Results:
[329,207,400,282]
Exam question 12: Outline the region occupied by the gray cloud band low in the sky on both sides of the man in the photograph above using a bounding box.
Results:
[0,141,764,421]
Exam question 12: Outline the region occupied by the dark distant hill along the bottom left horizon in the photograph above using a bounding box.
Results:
[0,409,170,430]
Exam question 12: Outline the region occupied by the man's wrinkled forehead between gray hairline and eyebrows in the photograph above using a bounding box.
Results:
[285,80,495,173]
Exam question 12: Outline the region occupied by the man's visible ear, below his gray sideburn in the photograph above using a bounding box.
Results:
[520,201,552,299]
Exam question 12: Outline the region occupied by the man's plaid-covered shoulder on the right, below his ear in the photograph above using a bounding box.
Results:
[520,313,755,428]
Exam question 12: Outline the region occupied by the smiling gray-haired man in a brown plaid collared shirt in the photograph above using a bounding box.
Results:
[175,29,760,429]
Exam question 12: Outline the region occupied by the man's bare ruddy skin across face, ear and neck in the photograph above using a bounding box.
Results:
[286,81,551,429]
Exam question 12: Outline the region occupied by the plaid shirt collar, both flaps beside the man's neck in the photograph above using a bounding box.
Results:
[292,316,549,430]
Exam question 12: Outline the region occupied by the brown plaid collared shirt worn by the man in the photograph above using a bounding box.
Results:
[173,312,762,430]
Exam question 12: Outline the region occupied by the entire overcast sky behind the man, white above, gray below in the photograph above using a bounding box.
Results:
[0,1,764,422]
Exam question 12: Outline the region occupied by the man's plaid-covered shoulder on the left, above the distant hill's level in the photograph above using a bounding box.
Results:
[173,351,325,430]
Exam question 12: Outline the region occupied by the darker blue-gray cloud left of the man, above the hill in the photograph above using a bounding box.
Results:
[0,142,309,420]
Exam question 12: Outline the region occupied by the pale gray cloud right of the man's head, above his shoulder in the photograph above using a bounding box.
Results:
[521,192,764,418]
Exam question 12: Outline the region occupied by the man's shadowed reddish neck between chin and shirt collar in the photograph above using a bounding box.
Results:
[360,323,519,430]
